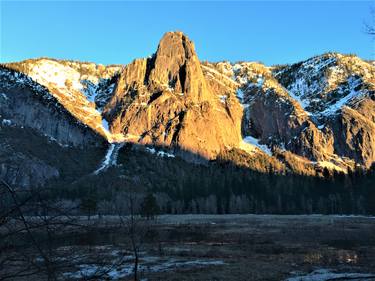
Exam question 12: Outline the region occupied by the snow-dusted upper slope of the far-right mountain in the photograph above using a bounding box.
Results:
[282,54,373,117]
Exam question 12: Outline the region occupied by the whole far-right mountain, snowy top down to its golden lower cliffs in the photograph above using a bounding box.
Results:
[274,53,375,168]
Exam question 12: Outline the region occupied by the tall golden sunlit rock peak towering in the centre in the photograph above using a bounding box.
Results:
[104,32,242,159]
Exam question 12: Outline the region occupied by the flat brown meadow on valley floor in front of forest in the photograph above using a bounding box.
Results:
[2,215,375,281]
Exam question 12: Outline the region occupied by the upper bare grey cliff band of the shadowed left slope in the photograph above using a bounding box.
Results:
[0,70,104,147]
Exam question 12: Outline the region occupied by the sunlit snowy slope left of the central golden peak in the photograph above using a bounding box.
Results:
[7,58,122,142]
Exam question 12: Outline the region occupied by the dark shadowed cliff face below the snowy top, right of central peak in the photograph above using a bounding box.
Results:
[248,85,334,161]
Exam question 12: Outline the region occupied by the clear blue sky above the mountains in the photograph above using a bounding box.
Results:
[0,0,375,65]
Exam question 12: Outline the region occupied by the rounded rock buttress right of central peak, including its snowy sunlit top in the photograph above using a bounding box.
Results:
[228,63,333,161]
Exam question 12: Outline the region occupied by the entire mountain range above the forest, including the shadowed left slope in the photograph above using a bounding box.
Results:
[0,32,375,186]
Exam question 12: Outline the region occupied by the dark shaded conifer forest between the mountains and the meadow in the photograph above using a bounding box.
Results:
[33,146,375,215]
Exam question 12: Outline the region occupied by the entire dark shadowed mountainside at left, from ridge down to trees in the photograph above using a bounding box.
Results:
[0,69,105,187]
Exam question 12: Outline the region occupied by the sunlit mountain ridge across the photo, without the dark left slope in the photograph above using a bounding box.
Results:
[0,32,375,188]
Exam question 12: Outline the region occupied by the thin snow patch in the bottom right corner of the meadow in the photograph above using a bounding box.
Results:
[285,269,375,281]
